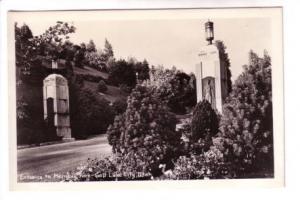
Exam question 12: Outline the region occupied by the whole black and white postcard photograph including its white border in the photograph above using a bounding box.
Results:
[8,8,284,189]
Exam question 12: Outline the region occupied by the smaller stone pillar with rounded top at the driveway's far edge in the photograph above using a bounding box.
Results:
[43,62,74,141]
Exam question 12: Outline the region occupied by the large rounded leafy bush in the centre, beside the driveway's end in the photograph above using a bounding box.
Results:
[107,85,180,176]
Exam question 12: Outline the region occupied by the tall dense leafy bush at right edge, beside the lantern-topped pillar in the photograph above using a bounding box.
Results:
[213,51,274,178]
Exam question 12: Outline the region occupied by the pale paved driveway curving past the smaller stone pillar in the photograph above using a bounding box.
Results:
[17,135,111,180]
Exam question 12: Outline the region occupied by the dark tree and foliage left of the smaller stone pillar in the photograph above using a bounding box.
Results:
[15,22,75,144]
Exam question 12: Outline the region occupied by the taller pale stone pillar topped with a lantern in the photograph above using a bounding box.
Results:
[196,21,228,113]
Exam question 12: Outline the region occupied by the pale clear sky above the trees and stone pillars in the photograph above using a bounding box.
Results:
[9,11,271,80]
